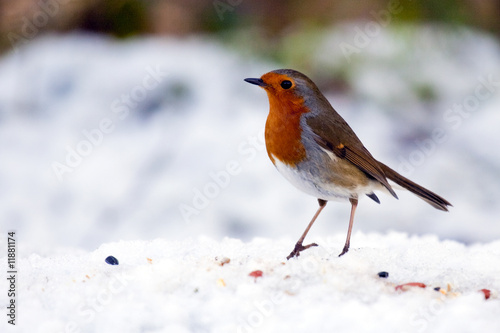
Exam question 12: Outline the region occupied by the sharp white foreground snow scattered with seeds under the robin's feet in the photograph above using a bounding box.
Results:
[2,232,500,332]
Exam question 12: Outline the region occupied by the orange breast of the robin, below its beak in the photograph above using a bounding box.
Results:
[265,93,309,166]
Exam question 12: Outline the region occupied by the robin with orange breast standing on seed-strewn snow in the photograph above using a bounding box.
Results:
[245,69,451,259]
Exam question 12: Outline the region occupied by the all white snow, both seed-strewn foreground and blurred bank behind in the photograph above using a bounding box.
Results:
[0,27,500,332]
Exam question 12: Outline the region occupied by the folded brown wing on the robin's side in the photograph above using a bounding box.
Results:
[306,102,398,198]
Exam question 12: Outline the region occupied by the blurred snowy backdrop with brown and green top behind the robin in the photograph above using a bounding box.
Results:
[0,0,500,256]
